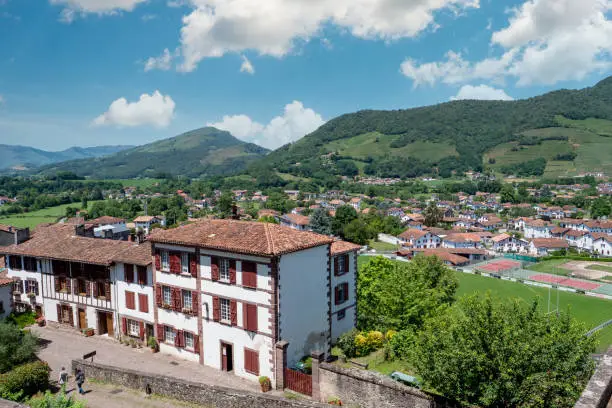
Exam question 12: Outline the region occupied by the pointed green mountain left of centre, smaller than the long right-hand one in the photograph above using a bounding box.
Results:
[40,127,268,178]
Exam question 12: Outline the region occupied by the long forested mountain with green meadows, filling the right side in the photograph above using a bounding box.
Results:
[266,77,612,177]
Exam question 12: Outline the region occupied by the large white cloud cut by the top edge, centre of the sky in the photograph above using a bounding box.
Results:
[170,0,480,71]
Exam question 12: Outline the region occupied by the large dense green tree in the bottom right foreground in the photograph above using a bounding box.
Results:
[413,294,596,407]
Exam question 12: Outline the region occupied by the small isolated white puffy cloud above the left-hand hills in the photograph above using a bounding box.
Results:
[93,91,175,127]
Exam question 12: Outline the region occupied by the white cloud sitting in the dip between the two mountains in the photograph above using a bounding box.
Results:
[208,101,325,149]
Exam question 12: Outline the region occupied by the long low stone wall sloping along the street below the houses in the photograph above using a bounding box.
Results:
[72,360,329,408]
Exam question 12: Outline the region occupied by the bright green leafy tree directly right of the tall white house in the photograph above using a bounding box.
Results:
[357,256,458,331]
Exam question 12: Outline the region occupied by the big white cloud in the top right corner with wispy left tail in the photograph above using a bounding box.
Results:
[400,0,612,86]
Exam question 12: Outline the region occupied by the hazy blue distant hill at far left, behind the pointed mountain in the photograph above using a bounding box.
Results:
[0,144,133,170]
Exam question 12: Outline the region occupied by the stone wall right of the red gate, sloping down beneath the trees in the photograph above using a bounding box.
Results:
[313,362,454,408]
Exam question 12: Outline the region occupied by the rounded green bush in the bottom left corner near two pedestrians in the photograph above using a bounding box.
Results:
[0,361,51,400]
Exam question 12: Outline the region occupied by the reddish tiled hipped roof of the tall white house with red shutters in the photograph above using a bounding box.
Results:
[149,220,333,256]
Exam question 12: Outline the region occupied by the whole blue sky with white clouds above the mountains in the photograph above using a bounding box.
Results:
[0,0,612,150]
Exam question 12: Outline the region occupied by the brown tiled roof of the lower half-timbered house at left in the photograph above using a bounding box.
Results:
[0,224,151,266]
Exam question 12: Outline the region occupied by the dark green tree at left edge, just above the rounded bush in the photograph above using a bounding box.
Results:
[0,322,38,373]
